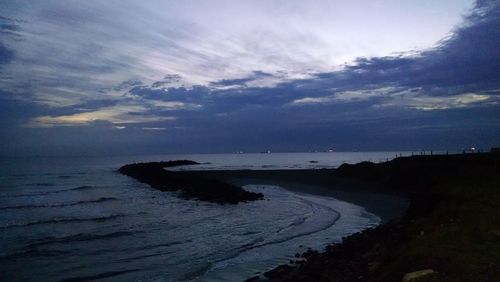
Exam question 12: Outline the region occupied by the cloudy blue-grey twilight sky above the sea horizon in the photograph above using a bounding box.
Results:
[0,0,500,156]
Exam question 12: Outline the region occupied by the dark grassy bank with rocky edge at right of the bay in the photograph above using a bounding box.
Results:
[250,154,500,281]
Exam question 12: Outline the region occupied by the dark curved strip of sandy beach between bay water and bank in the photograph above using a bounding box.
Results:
[181,169,409,279]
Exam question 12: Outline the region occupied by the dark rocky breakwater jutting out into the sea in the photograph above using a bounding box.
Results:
[118,160,264,204]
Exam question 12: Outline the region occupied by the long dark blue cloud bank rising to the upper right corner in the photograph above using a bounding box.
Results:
[131,1,500,116]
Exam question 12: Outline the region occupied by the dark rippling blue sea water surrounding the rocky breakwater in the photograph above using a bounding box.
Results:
[0,152,407,281]
